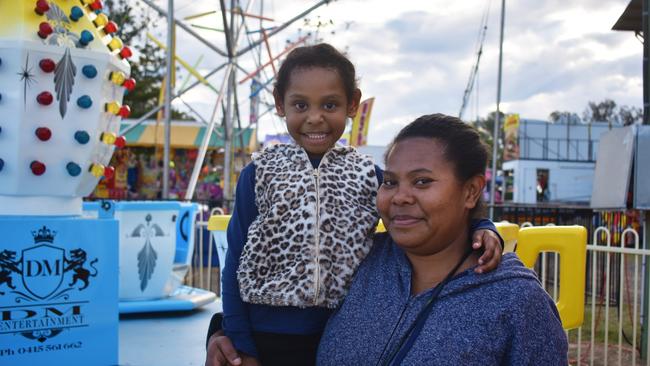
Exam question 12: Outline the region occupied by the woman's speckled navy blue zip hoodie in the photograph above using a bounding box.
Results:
[318,235,568,365]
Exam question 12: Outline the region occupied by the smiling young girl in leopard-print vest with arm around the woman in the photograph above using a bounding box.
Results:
[206,44,500,365]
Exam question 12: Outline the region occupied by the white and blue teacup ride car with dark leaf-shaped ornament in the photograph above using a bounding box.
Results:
[84,201,216,314]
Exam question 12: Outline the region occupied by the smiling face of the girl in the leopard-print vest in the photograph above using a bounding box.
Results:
[275,67,361,156]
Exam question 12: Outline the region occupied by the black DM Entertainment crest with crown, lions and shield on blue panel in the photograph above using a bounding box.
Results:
[0,226,98,342]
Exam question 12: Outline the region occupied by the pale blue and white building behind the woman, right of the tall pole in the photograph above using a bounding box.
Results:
[502,116,609,205]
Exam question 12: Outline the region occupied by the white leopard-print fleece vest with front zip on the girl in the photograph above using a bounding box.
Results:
[237,144,378,308]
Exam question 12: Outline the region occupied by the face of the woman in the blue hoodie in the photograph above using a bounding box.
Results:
[377,137,485,255]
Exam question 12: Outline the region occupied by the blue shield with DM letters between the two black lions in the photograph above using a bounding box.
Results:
[22,245,65,300]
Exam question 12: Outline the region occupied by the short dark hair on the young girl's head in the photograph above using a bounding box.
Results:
[273,43,357,102]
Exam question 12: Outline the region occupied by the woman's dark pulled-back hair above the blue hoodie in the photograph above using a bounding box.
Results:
[384,114,488,218]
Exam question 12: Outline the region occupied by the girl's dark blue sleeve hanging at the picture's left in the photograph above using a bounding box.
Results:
[221,163,259,357]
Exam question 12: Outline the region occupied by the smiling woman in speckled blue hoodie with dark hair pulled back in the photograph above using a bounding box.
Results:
[318,114,568,365]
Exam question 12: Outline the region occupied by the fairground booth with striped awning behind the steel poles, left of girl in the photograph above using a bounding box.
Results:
[92,120,257,206]
